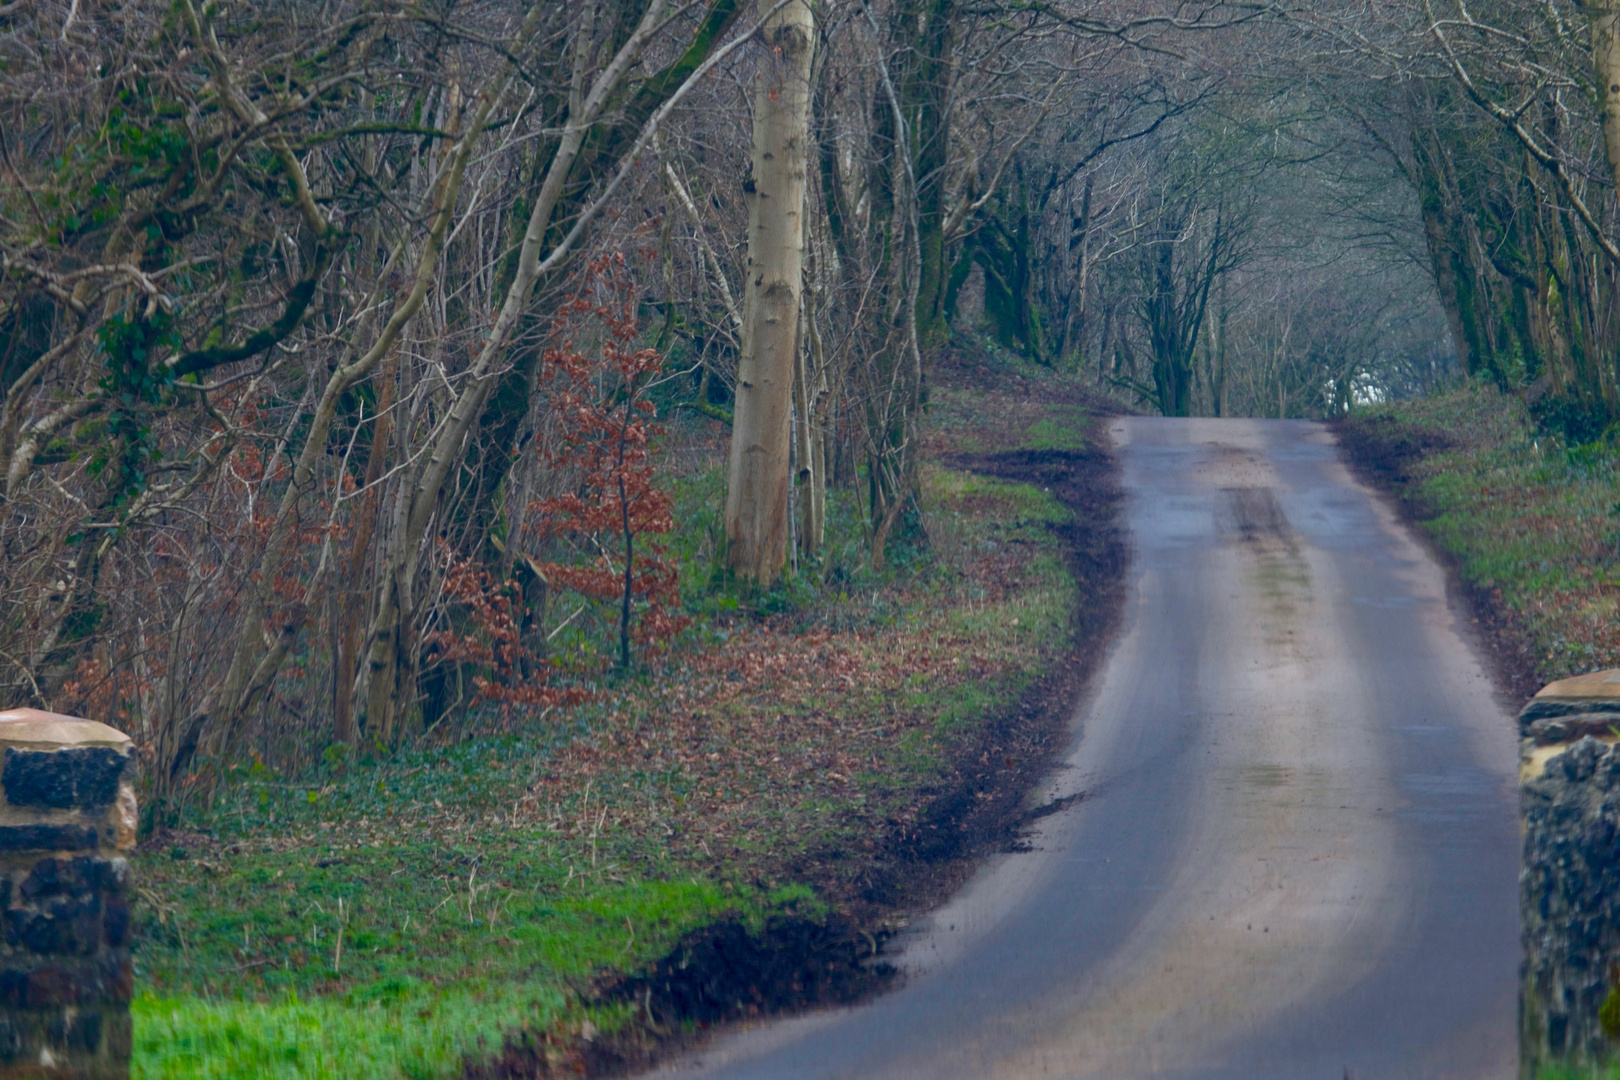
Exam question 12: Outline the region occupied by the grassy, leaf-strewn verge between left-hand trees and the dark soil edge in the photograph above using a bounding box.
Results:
[134,340,1092,1078]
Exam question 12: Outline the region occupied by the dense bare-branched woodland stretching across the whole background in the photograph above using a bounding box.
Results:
[0,0,1620,797]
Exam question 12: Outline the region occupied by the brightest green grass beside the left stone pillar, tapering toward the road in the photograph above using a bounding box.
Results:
[133,881,818,1080]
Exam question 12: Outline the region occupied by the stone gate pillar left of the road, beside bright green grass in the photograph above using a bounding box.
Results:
[0,709,136,1080]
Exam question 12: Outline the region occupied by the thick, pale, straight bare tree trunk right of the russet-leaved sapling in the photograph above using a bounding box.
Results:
[726,0,815,586]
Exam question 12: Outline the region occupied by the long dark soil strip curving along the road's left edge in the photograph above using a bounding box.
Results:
[463,385,1128,1080]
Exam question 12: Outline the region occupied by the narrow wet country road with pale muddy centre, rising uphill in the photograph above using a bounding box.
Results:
[641,418,1518,1080]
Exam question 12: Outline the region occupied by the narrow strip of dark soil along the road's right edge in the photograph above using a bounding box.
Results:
[1333,409,1552,711]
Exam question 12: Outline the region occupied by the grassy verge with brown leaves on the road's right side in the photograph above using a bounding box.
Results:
[1346,384,1620,678]
